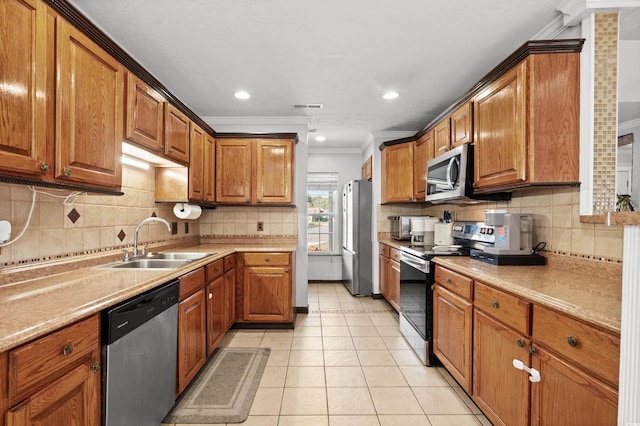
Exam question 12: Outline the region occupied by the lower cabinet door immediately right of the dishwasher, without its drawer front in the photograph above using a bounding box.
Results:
[177,289,207,395]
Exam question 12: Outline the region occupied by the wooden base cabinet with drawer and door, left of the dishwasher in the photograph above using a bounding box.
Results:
[0,315,101,426]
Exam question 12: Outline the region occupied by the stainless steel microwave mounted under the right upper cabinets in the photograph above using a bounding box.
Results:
[425,144,511,204]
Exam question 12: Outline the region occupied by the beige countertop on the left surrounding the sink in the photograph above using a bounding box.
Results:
[0,243,296,352]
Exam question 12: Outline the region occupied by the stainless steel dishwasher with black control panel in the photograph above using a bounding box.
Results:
[102,280,180,426]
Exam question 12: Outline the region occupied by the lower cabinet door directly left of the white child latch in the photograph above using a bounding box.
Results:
[473,309,531,426]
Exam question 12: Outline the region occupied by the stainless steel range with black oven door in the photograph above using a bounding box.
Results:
[400,222,495,366]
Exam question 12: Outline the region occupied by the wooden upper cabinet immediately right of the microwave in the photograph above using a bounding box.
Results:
[473,53,580,192]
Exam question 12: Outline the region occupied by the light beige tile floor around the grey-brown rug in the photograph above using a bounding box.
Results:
[162,283,491,426]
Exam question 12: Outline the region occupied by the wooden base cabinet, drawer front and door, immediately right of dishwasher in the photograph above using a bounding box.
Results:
[176,268,207,396]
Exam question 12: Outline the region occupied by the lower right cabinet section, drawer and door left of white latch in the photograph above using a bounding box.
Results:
[472,282,531,426]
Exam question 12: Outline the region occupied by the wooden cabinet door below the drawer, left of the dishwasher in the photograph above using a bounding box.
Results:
[7,360,100,426]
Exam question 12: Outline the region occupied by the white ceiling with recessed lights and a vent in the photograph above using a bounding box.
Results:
[63,0,620,148]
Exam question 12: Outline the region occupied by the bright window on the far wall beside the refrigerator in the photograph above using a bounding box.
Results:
[307,173,340,254]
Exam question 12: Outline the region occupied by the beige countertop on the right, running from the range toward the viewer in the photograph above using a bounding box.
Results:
[434,256,622,335]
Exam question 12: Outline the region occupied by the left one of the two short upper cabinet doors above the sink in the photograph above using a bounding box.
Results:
[125,72,165,153]
